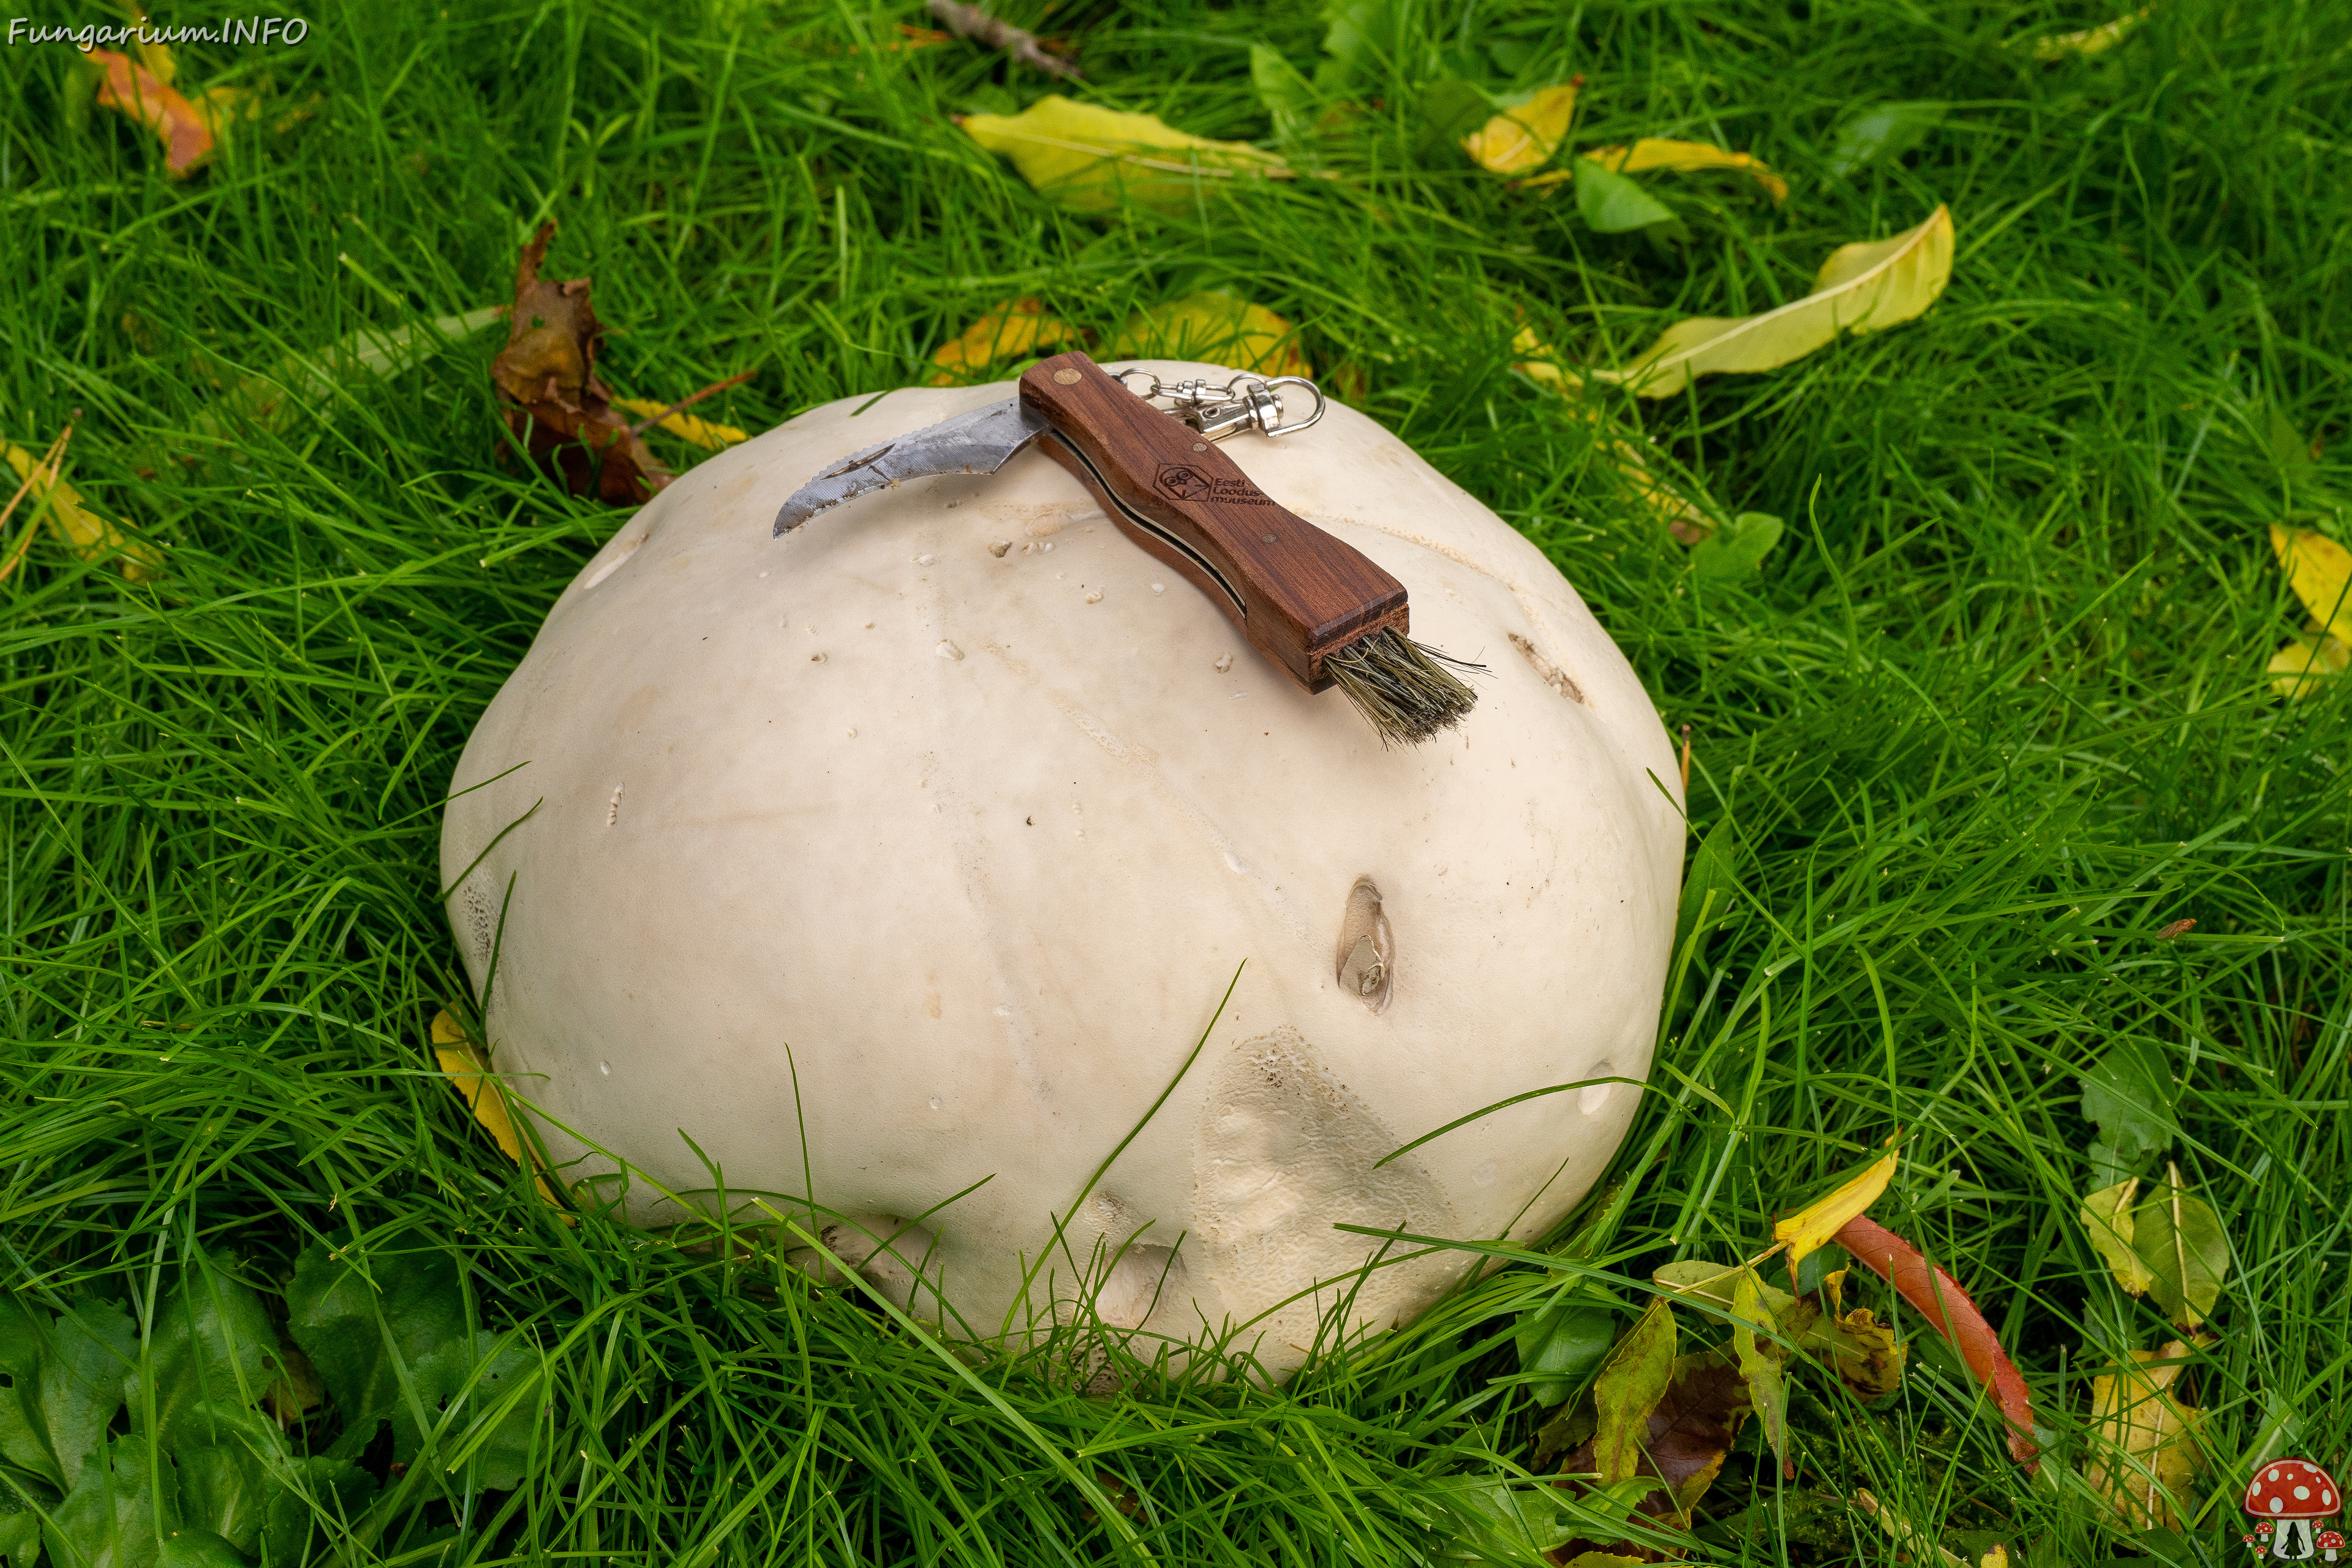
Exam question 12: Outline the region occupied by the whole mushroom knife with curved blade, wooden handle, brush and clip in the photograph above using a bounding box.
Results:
[776,353,1475,741]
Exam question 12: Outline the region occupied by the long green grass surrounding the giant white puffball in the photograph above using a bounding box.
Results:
[0,0,2352,1563]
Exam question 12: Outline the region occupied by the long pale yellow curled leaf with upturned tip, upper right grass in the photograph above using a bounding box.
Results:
[1593,207,1952,398]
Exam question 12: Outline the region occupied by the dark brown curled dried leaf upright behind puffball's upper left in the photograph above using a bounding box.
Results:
[489,224,670,505]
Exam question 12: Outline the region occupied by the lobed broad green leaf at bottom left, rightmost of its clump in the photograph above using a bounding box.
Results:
[287,1246,543,1490]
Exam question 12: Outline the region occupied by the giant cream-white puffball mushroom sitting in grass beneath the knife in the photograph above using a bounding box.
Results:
[442,362,1684,1375]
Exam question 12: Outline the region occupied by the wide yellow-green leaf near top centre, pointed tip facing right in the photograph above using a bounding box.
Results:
[962,92,1291,211]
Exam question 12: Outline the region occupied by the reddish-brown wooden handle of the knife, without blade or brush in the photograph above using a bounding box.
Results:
[1021,353,1409,691]
